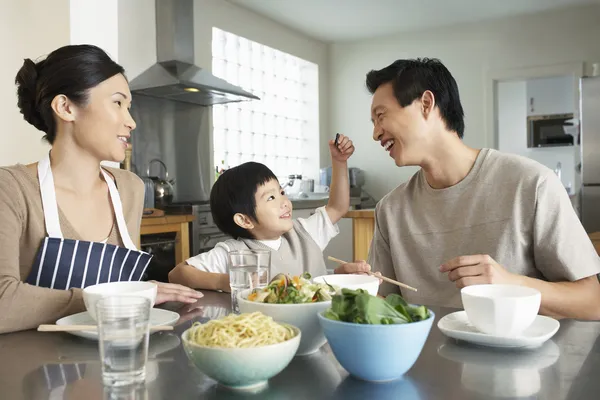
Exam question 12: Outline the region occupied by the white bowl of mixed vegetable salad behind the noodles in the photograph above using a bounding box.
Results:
[238,273,340,356]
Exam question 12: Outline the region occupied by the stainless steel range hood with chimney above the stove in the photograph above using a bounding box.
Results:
[129,0,260,106]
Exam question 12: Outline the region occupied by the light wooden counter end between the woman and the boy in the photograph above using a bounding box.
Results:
[140,214,196,264]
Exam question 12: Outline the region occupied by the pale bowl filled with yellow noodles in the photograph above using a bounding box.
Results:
[182,312,301,391]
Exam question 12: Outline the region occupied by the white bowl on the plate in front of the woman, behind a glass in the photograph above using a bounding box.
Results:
[83,281,157,321]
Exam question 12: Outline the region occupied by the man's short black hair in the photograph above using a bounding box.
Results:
[366,58,465,139]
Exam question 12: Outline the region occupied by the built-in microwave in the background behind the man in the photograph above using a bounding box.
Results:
[527,114,574,147]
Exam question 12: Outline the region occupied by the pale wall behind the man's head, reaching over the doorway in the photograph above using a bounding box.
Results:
[330,6,600,202]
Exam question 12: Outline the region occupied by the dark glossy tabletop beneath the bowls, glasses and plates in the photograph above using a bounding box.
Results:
[0,292,600,400]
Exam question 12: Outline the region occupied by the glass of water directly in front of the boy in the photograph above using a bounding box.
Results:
[229,250,271,314]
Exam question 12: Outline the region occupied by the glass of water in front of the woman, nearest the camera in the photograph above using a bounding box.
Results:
[96,296,151,386]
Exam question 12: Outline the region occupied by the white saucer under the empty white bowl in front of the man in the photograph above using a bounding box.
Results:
[438,311,560,348]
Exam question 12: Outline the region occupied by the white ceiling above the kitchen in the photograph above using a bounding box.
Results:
[228,0,600,42]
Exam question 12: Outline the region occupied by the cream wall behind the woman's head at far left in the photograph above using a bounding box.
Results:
[0,0,69,165]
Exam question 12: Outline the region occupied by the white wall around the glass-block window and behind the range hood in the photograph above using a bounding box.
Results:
[119,0,328,180]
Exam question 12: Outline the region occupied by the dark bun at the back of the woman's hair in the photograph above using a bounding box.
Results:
[15,58,48,132]
